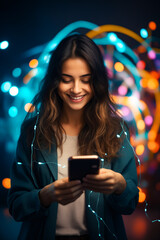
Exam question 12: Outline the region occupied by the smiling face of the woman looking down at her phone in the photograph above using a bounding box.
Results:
[58,58,93,111]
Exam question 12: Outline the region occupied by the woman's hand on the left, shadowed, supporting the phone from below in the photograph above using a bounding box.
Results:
[39,178,83,207]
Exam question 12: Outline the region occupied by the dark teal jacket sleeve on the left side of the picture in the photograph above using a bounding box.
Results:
[8,126,48,221]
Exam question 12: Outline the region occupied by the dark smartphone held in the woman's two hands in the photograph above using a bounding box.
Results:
[68,155,100,181]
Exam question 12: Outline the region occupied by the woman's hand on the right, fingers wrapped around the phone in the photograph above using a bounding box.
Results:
[83,168,126,194]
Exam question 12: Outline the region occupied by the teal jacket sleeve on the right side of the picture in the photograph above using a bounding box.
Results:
[105,129,139,214]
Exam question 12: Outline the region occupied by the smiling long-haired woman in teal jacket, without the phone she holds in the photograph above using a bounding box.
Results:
[8,34,138,240]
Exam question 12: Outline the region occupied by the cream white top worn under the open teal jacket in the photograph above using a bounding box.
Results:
[56,136,87,236]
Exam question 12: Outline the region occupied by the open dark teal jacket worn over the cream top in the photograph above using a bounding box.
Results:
[8,120,139,240]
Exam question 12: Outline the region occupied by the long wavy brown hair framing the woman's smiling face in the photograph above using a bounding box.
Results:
[26,34,122,160]
